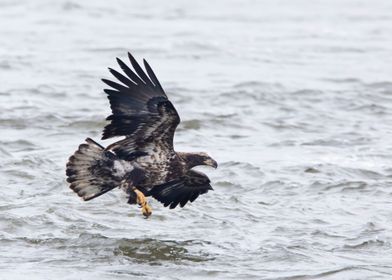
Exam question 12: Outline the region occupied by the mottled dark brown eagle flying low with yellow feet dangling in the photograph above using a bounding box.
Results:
[66,53,218,217]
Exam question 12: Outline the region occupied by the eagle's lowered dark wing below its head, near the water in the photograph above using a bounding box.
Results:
[149,170,212,209]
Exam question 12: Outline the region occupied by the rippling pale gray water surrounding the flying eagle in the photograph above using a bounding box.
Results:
[0,0,392,280]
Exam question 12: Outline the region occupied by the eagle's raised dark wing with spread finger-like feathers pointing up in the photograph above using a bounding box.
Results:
[102,53,180,159]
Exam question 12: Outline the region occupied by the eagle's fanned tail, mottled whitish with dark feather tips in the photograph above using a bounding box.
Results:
[66,138,120,201]
